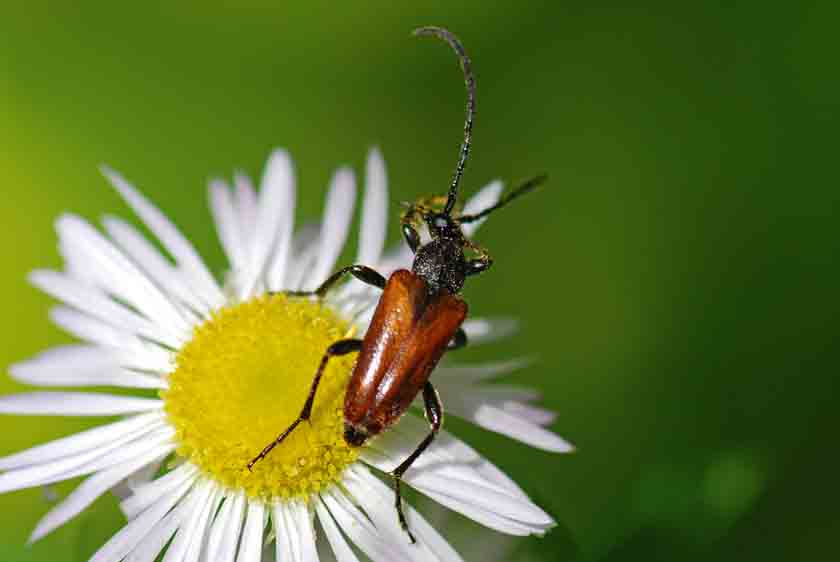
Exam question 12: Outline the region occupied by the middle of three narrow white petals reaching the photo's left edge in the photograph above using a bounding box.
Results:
[0,412,161,470]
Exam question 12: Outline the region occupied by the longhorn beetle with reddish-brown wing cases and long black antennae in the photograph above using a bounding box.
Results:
[248,27,545,542]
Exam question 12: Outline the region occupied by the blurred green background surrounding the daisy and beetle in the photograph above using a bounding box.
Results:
[0,1,840,562]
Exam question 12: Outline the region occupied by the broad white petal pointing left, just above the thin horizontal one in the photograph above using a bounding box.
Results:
[9,345,166,388]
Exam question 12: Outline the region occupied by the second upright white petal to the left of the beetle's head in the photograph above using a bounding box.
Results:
[304,168,356,289]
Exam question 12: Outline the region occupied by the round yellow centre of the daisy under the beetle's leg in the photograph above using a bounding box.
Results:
[161,295,357,500]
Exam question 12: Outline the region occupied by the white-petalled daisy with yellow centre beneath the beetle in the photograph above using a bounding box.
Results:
[0,150,571,562]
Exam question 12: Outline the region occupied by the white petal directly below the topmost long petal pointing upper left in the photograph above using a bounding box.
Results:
[102,216,210,315]
